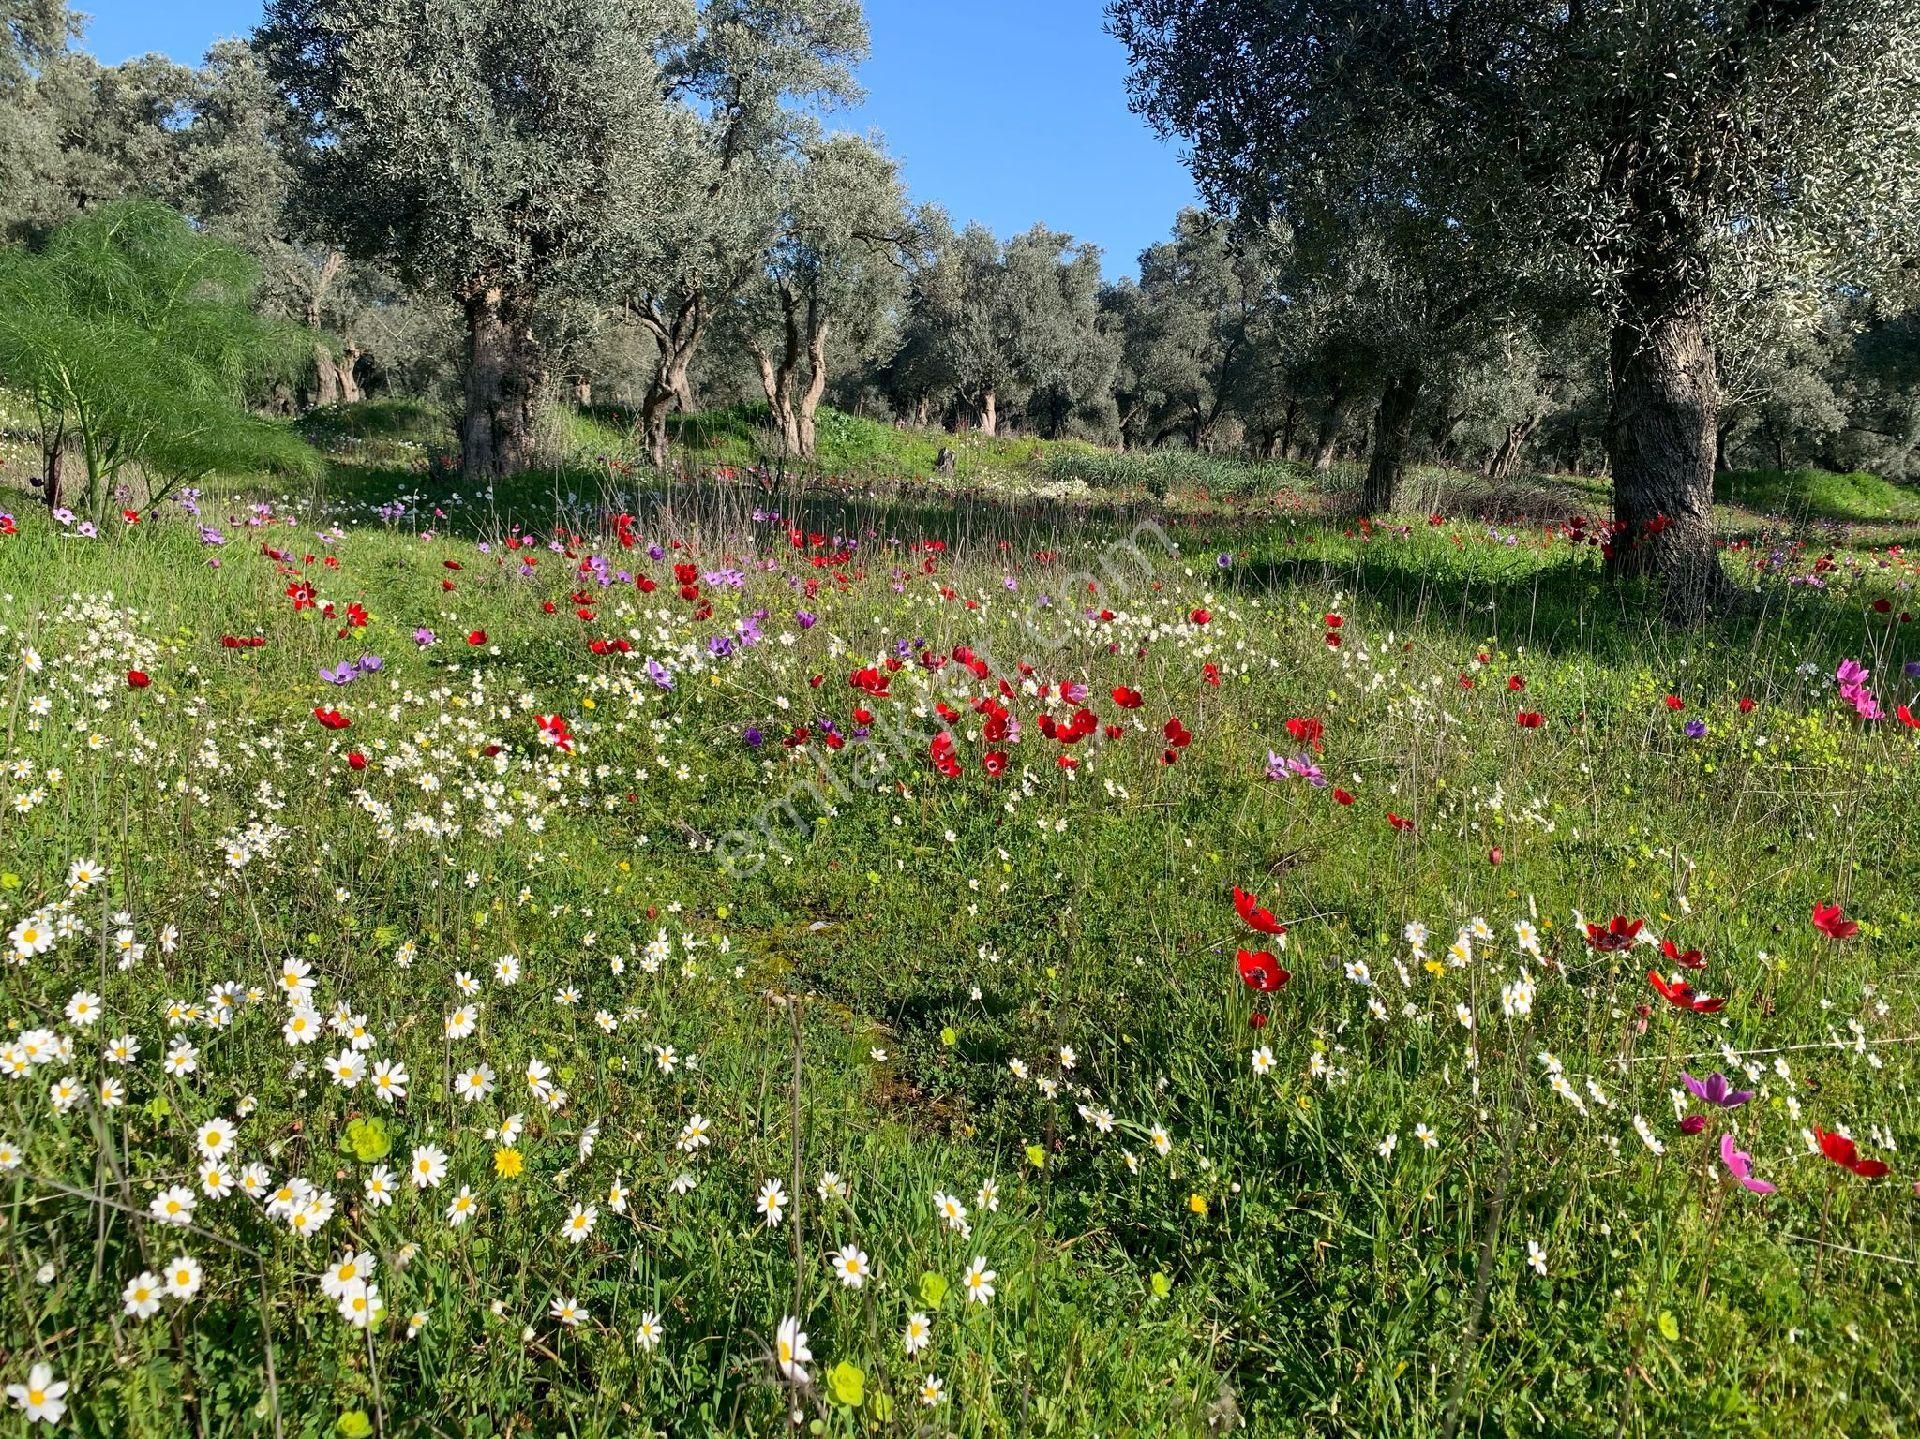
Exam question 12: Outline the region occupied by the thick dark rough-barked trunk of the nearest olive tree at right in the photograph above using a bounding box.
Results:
[1607,286,1732,622]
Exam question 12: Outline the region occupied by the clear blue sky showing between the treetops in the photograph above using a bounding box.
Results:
[79,0,1194,275]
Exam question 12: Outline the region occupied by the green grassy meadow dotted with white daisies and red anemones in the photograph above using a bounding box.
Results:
[0,411,1920,1439]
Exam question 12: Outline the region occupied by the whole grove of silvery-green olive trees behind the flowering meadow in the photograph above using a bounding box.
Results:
[0,0,1920,611]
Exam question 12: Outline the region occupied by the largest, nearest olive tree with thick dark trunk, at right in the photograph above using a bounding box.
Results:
[1110,0,1920,619]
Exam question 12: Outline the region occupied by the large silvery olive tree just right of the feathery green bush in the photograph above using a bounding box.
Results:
[255,0,693,478]
